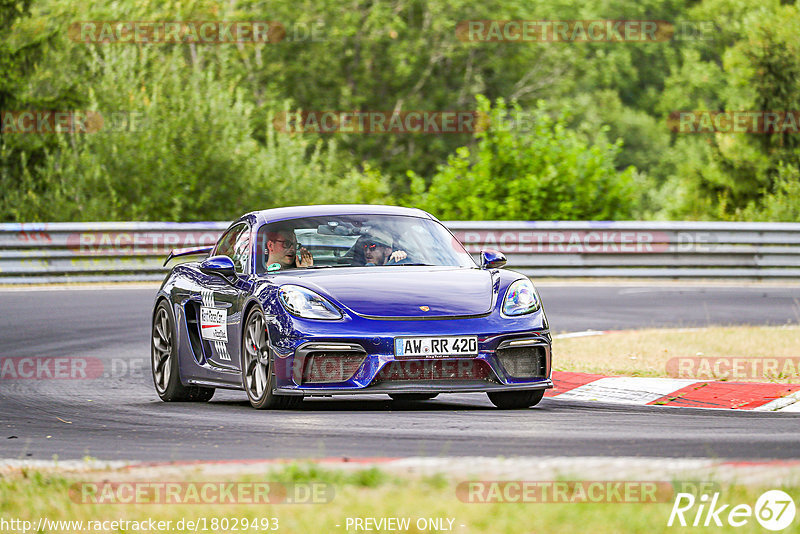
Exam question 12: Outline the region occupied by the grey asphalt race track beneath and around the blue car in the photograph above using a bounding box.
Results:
[0,283,800,461]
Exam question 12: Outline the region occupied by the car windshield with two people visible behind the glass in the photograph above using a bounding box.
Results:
[256,215,476,273]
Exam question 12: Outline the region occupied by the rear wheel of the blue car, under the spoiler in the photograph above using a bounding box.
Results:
[150,300,214,402]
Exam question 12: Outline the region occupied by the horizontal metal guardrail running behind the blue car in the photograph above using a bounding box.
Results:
[0,221,800,283]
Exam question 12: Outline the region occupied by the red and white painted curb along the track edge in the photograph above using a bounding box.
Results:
[545,371,800,413]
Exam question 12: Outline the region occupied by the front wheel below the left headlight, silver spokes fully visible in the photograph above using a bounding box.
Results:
[241,307,303,410]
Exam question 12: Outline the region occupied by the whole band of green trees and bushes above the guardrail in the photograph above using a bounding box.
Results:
[0,0,800,221]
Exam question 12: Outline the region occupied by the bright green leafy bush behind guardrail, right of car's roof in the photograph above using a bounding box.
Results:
[406,97,640,220]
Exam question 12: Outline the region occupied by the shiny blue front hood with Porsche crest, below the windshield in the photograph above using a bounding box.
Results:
[276,266,499,318]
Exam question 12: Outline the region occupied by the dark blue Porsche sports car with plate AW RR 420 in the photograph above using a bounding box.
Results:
[151,205,553,409]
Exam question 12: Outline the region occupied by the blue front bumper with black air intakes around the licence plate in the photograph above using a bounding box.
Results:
[269,312,553,396]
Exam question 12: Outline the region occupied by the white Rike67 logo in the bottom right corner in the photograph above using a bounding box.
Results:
[667,490,796,532]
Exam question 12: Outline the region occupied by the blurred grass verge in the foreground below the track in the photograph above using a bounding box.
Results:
[0,465,800,534]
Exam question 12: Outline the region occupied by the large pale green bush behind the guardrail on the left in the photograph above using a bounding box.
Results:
[3,47,388,221]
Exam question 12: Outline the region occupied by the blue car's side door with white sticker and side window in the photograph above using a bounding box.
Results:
[198,223,250,370]
